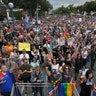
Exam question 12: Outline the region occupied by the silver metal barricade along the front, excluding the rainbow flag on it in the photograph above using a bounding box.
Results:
[11,83,79,96]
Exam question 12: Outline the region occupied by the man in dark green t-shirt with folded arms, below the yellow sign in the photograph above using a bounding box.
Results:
[18,58,32,82]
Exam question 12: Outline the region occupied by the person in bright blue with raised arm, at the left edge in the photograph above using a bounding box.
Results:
[0,62,15,96]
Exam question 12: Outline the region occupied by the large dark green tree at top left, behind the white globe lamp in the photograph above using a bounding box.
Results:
[4,0,53,16]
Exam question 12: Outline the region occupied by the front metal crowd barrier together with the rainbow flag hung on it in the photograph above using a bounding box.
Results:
[11,83,79,96]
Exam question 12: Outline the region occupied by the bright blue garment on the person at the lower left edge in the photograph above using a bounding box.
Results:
[0,71,14,92]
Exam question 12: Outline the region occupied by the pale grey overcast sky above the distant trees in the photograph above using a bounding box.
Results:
[48,0,92,9]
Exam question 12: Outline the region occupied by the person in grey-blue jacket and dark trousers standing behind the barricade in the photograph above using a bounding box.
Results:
[31,66,44,96]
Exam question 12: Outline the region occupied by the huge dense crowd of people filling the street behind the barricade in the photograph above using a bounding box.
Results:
[0,15,96,96]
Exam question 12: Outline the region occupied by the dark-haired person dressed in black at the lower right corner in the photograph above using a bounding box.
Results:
[80,70,93,96]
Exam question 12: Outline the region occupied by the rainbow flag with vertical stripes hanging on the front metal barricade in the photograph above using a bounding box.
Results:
[58,83,73,96]
